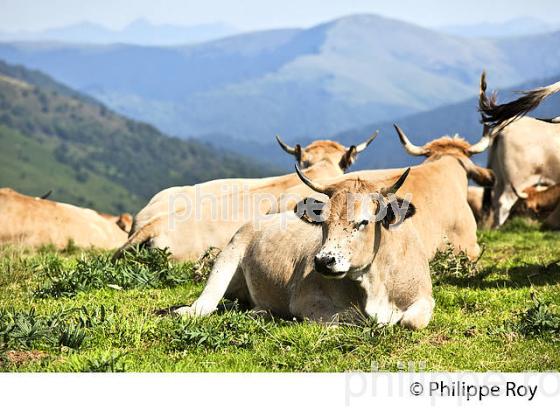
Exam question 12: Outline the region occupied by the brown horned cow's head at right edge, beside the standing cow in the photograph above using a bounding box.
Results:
[511,184,560,230]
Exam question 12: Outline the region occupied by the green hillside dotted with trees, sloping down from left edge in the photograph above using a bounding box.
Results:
[0,63,273,212]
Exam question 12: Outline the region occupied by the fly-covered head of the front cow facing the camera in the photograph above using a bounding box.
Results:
[296,167,415,279]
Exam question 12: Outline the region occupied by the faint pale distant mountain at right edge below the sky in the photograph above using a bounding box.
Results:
[439,17,560,38]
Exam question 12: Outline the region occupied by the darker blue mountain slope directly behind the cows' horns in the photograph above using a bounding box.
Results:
[203,73,560,170]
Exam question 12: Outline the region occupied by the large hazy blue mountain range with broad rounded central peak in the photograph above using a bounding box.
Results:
[0,15,560,143]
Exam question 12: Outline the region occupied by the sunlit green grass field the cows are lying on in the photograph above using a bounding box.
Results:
[0,220,560,372]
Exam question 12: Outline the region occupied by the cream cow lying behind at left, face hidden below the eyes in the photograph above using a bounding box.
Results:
[114,133,377,260]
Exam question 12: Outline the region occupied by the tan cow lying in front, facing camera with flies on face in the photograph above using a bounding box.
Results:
[175,169,434,329]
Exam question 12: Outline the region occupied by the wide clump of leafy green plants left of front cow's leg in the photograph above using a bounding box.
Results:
[35,249,193,297]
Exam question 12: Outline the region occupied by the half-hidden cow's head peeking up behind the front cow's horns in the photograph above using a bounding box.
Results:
[276,132,378,171]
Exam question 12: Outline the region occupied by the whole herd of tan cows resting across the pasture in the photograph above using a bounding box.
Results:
[0,74,560,329]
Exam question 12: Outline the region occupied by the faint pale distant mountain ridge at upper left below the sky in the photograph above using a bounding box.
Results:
[0,19,238,45]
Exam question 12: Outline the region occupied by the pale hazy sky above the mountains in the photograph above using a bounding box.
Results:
[0,0,560,31]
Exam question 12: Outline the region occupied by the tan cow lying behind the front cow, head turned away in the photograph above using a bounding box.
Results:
[281,125,494,260]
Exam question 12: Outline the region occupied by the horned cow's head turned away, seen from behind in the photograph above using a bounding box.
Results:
[395,124,496,187]
